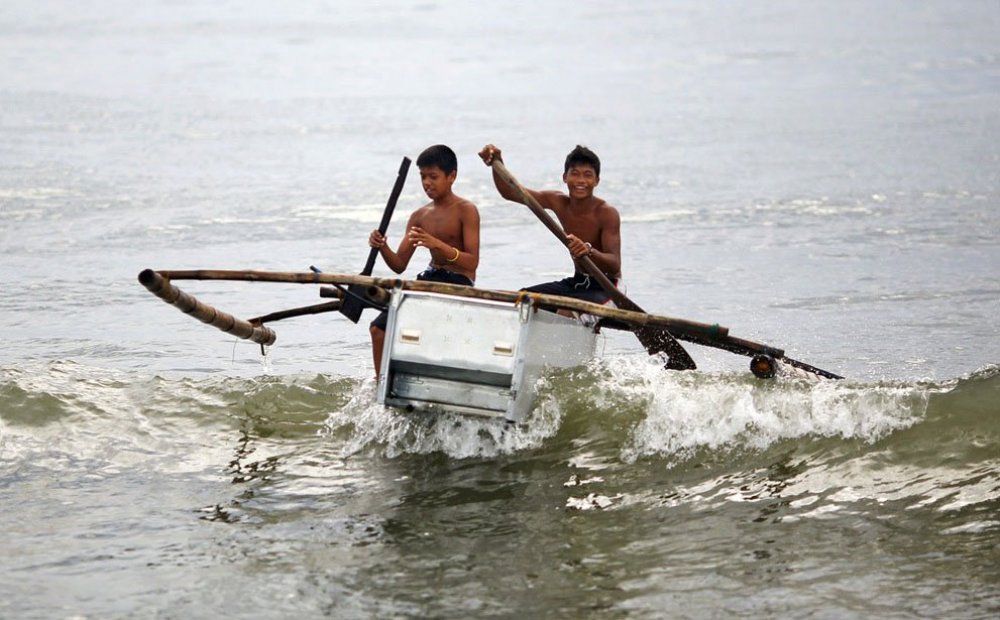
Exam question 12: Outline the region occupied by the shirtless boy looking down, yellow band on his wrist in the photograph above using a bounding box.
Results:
[368,144,479,377]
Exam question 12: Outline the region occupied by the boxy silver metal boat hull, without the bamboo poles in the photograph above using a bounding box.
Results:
[378,288,597,423]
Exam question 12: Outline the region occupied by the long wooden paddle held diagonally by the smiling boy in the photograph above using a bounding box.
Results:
[488,158,696,370]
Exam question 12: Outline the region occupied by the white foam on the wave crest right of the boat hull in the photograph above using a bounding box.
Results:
[595,357,928,461]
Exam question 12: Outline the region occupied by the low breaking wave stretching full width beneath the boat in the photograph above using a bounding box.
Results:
[0,356,1000,469]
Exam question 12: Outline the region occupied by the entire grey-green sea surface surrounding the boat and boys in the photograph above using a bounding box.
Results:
[0,1,1000,618]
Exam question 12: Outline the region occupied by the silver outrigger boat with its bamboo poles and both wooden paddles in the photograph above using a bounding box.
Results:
[139,157,842,423]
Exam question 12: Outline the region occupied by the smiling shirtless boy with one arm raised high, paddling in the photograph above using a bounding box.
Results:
[479,144,622,304]
